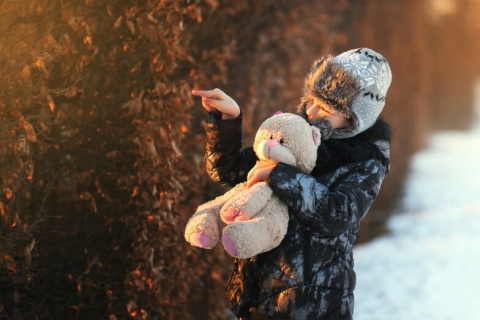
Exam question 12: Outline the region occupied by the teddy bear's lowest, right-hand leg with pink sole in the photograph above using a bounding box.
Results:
[222,197,288,259]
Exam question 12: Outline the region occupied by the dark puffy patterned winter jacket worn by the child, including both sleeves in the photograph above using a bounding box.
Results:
[205,114,390,320]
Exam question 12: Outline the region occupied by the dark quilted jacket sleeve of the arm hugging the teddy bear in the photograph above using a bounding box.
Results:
[268,160,386,236]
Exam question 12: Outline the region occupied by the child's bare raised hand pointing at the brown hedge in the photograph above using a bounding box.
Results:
[192,88,240,120]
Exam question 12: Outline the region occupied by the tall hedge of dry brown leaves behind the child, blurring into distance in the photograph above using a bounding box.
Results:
[0,0,480,320]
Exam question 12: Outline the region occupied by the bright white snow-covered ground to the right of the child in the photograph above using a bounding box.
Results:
[354,83,480,320]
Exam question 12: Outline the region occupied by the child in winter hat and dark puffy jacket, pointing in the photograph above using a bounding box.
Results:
[192,48,392,320]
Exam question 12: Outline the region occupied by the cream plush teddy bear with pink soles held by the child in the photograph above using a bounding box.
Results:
[185,113,320,259]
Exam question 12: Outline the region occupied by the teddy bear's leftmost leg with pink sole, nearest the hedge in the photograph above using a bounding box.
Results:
[184,185,245,249]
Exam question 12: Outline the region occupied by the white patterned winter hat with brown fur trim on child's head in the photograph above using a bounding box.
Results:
[302,48,392,139]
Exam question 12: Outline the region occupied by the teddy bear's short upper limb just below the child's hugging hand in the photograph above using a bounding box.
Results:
[220,182,273,224]
